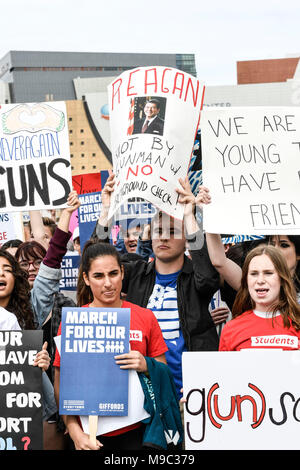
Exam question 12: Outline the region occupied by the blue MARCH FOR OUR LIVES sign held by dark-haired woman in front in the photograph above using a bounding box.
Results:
[59,307,130,416]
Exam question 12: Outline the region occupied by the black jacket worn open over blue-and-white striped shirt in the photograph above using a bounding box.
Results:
[122,239,220,351]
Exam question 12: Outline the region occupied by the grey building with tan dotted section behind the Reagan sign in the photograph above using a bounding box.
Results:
[0,51,196,175]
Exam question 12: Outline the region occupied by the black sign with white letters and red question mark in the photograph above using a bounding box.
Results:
[0,331,43,450]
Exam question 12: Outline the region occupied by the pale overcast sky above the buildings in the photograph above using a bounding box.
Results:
[0,0,300,85]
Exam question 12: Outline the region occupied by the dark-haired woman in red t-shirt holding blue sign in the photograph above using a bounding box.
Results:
[54,241,167,450]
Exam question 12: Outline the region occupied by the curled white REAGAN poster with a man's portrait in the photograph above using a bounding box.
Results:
[108,67,204,219]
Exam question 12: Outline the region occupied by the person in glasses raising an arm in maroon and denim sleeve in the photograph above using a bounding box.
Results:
[15,191,80,450]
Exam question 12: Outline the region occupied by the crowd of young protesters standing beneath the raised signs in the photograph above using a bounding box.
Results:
[0,172,300,450]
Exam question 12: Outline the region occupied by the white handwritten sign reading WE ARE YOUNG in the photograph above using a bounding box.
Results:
[201,107,300,235]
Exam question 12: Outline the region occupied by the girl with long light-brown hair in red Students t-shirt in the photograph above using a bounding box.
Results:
[219,245,300,351]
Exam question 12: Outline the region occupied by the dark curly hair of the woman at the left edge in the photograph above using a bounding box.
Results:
[0,248,35,330]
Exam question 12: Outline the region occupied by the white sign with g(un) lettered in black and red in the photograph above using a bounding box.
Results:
[182,349,300,450]
